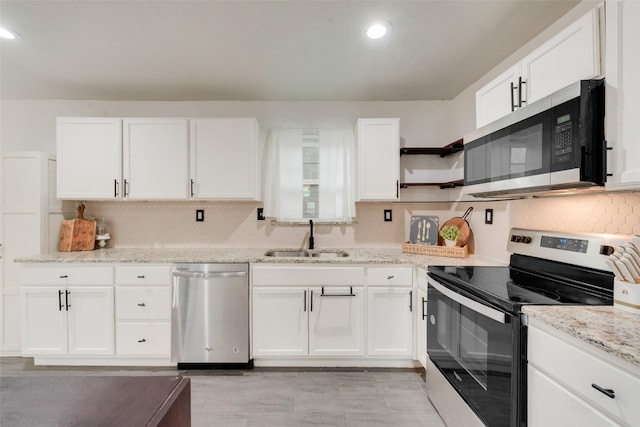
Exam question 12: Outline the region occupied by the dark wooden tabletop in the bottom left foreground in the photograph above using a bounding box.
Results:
[0,376,191,427]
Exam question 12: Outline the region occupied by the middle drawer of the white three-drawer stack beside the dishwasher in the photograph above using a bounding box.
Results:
[116,286,171,319]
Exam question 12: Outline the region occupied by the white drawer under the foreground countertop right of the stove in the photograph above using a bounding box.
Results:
[528,327,640,423]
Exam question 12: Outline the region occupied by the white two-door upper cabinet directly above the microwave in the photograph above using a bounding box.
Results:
[476,8,601,128]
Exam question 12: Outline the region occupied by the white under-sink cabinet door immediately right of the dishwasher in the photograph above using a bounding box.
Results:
[252,287,309,357]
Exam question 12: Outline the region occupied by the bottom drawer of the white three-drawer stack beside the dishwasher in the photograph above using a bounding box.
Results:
[116,322,171,356]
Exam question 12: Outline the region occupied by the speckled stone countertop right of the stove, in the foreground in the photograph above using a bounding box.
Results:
[524,305,640,371]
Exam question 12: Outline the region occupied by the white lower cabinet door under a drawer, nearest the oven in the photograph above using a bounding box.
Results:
[367,287,413,357]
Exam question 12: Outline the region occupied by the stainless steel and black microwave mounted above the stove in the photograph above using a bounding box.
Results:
[464,80,607,197]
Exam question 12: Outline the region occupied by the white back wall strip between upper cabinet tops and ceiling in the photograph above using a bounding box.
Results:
[0,100,451,154]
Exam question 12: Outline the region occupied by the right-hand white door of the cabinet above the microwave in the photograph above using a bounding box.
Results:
[522,8,600,104]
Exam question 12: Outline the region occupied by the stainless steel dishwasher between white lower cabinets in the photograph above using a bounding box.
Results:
[171,263,253,369]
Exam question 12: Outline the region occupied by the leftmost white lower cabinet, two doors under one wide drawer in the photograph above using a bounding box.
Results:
[20,267,114,356]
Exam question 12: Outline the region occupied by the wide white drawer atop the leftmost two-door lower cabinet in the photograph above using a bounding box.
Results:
[22,266,113,286]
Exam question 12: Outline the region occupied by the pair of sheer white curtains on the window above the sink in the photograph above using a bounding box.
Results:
[263,128,356,222]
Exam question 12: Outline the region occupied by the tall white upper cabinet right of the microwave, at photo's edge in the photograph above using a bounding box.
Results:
[605,1,640,190]
